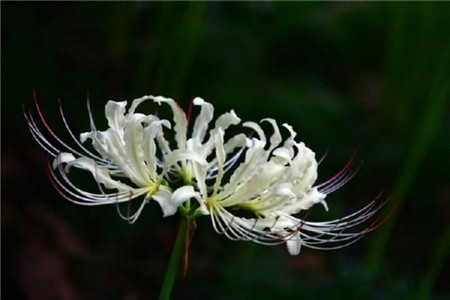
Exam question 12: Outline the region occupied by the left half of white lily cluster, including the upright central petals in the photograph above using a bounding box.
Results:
[25,93,245,223]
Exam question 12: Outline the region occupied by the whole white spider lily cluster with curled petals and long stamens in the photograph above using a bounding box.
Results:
[25,95,384,255]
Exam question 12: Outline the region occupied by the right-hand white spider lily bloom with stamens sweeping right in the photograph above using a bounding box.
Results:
[189,119,381,255]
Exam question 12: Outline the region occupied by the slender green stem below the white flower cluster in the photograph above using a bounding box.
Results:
[159,217,188,300]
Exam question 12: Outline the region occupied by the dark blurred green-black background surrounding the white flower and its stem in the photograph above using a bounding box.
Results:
[1,2,450,300]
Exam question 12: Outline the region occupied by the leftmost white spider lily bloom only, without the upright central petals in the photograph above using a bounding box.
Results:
[25,94,206,223]
